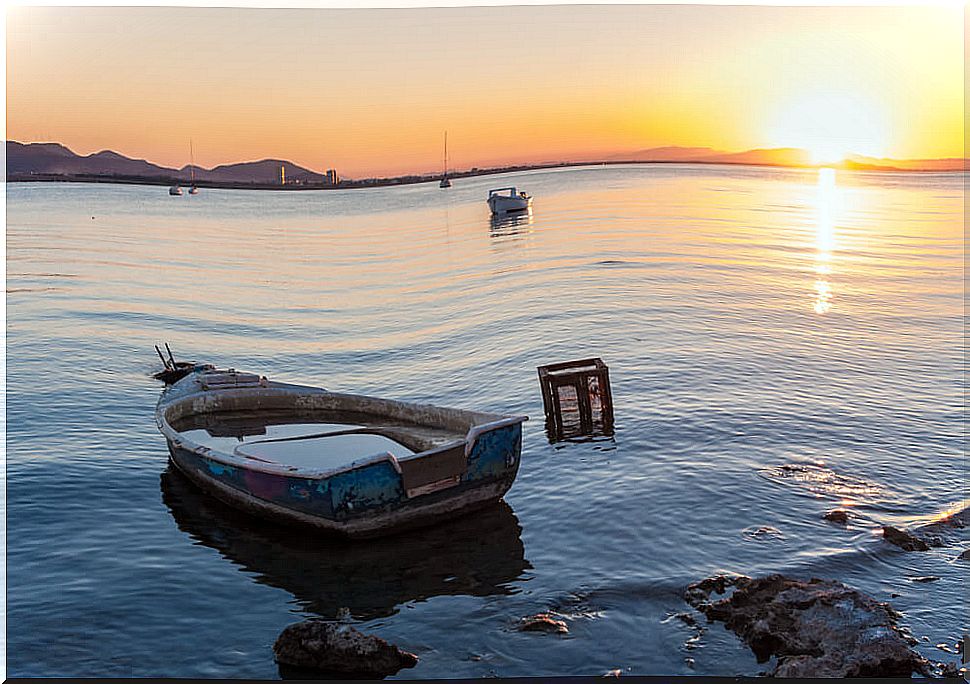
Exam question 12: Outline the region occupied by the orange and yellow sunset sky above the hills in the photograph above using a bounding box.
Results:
[7,5,964,177]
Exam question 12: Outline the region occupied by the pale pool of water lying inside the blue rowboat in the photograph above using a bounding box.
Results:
[173,412,417,469]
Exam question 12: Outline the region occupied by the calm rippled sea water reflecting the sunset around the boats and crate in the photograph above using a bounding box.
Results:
[6,165,970,678]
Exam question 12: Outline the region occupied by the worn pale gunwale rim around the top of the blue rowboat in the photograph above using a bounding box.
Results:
[155,382,529,480]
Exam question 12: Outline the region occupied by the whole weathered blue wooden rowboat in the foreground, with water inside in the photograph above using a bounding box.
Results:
[155,367,528,537]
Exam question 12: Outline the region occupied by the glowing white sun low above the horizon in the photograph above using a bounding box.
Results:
[769,91,887,165]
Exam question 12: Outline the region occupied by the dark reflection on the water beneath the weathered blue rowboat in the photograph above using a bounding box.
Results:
[161,465,532,619]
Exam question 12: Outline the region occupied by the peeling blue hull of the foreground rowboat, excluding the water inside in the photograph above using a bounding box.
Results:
[156,372,526,538]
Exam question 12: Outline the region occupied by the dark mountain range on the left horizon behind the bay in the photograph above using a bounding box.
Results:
[7,140,325,184]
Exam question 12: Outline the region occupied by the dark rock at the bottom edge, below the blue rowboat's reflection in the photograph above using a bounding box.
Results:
[273,620,418,677]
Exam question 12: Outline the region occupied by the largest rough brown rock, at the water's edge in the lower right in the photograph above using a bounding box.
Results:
[686,575,922,678]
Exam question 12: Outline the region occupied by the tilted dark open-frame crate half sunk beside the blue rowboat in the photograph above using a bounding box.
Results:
[538,358,613,440]
